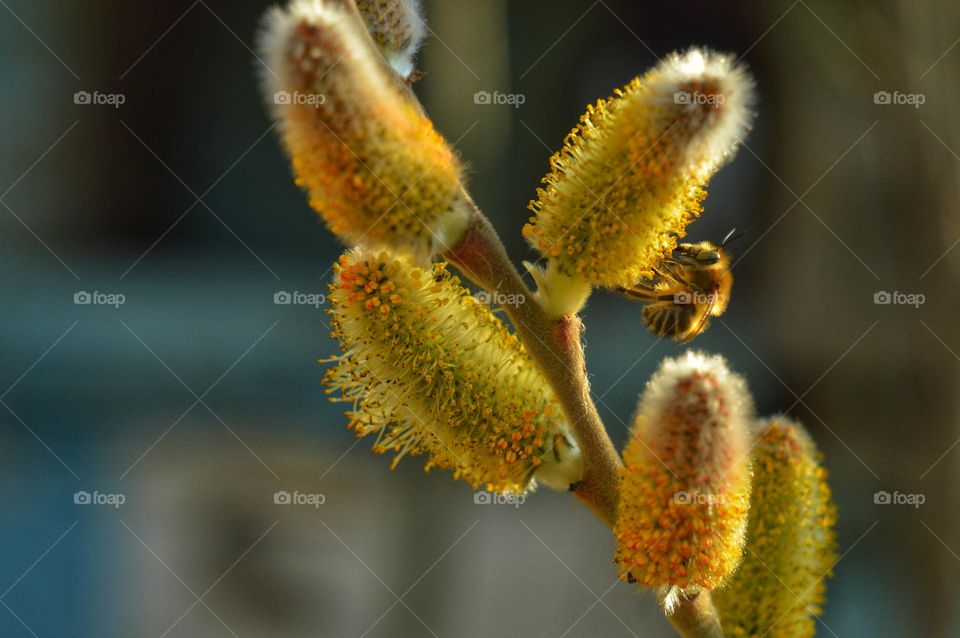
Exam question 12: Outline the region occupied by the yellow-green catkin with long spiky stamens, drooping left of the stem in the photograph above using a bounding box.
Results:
[325,248,581,492]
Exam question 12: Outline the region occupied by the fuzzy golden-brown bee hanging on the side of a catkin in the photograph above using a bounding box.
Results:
[620,229,743,343]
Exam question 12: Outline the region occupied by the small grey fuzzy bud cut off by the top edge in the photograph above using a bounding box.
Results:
[357,0,427,78]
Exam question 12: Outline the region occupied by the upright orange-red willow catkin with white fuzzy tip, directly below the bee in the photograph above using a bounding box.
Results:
[614,352,753,613]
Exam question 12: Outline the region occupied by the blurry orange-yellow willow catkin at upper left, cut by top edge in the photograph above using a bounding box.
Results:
[260,0,468,259]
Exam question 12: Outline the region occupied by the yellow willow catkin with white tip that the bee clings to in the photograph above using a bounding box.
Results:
[523,49,753,287]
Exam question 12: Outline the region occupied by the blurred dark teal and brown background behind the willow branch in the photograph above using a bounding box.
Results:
[0,0,960,637]
